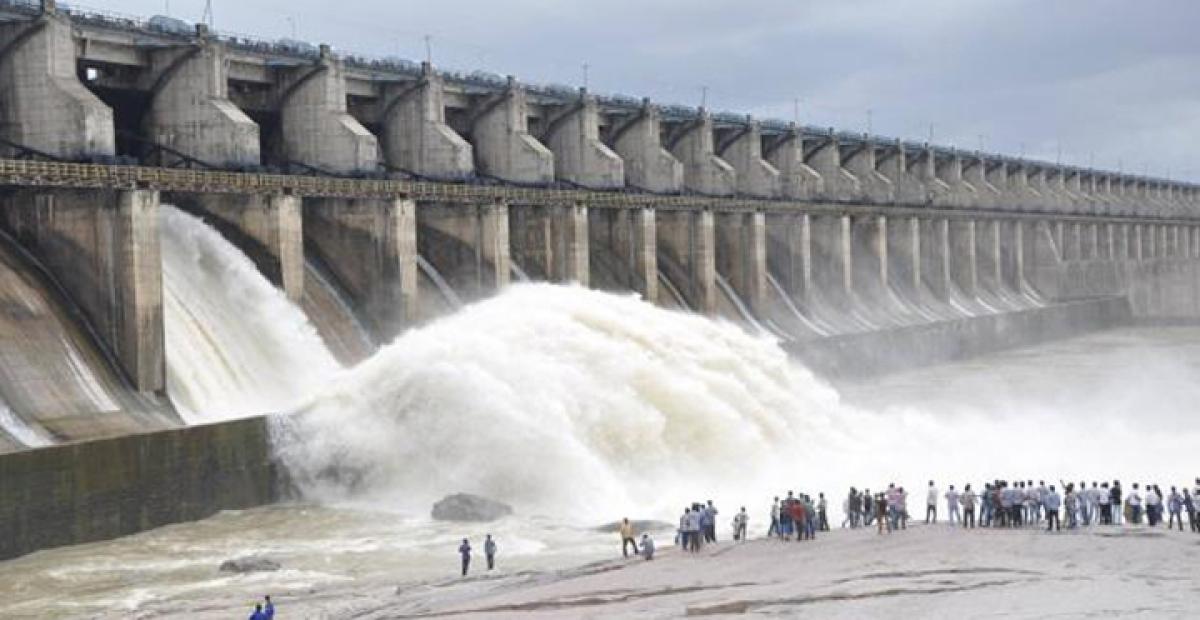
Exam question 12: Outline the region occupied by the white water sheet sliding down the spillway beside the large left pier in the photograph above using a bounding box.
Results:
[160,205,341,423]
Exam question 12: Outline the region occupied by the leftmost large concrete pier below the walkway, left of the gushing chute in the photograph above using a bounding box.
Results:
[0,189,166,392]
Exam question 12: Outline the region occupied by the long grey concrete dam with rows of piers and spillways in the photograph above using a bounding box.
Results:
[0,0,1200,556]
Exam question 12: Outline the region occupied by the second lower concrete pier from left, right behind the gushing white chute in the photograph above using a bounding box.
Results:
[169,194,305,301]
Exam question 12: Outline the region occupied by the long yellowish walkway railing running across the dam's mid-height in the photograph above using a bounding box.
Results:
[0,158,1200,225]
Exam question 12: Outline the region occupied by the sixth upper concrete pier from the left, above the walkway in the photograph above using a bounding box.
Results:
[545,90,625,188]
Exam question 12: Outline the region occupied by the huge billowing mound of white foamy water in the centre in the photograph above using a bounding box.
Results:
[274,284,838,512]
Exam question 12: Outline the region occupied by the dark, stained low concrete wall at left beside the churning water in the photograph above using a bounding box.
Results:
[0,417,283,561]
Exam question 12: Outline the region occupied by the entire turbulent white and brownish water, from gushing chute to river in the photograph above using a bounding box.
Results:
[0,211,1200,616]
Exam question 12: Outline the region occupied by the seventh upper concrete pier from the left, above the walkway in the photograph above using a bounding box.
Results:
[610,101,683,193]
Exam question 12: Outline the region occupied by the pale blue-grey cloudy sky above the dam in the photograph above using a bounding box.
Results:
[100,0,1200,181]
